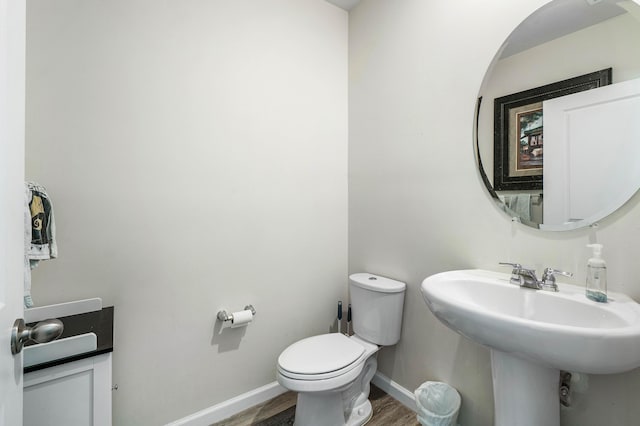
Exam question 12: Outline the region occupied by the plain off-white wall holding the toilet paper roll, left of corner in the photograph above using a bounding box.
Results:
[26,0,348,425]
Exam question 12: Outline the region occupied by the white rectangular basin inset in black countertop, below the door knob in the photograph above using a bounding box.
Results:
[23,333,98,368]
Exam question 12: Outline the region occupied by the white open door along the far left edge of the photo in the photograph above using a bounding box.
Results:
[0,0,26,426]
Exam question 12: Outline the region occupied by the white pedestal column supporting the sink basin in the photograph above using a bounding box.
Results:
[491,349,560,426]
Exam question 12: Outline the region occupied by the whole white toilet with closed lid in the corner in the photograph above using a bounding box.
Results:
[277,273,406,426]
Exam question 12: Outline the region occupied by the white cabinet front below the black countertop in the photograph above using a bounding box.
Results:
[23,353,111,426]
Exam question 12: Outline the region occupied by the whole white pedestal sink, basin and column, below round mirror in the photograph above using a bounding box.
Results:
[421,270,640,426]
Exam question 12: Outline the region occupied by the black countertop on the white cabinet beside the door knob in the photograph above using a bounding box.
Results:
[24,306,113,373]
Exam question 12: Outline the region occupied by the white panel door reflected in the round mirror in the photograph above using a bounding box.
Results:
[540,79,640,229]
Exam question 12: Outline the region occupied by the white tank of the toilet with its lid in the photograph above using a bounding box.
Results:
[349,273,407,346]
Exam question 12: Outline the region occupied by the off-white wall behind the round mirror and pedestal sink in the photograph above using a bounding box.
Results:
[349,0,640,426]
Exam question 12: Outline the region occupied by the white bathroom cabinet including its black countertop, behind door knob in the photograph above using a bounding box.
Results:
[23,301,114,426]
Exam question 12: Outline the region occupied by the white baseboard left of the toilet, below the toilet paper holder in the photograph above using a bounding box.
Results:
[166,382,287,426]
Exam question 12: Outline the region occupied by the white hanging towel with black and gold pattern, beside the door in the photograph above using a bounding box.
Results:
[24,182,58,308]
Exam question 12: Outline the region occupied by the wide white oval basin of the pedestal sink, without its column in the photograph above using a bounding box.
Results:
[421,270,640,374]
